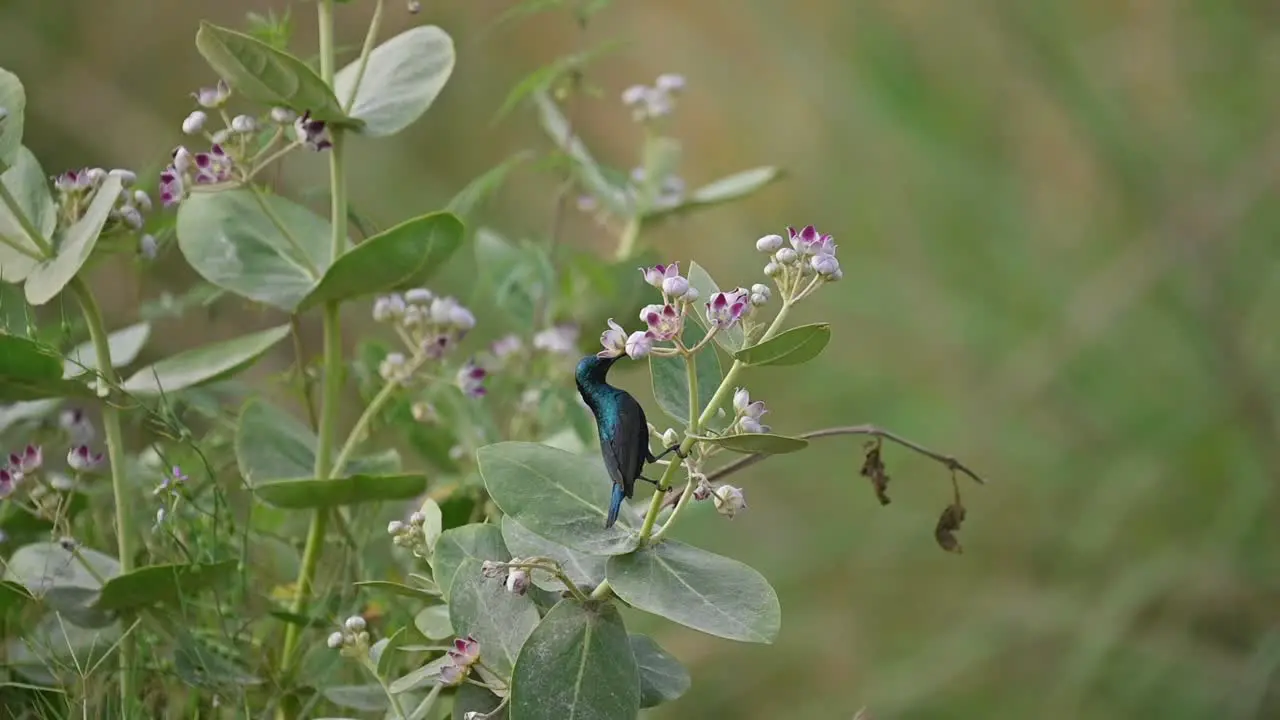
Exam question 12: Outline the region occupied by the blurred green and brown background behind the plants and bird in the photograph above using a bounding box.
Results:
[0,0,1280,720]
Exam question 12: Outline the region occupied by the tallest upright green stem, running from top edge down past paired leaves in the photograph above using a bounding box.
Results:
[280,0,347,702]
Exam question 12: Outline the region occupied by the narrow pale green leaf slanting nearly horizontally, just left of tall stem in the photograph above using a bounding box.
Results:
[123,324,289,395]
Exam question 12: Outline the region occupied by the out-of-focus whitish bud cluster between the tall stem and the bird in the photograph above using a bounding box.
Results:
[374,287,489,397]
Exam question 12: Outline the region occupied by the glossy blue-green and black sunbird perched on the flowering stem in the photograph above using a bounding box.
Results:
[573,355,684,529]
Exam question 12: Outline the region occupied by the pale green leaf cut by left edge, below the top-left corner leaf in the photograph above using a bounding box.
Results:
[0,147,58,283]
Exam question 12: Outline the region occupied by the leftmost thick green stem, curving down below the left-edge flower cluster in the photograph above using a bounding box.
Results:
[68,277,138,715]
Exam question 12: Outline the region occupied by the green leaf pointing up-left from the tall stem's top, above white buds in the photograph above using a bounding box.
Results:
[196,22,349,124]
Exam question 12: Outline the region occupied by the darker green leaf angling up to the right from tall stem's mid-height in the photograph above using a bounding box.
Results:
[297,207,462,313]
